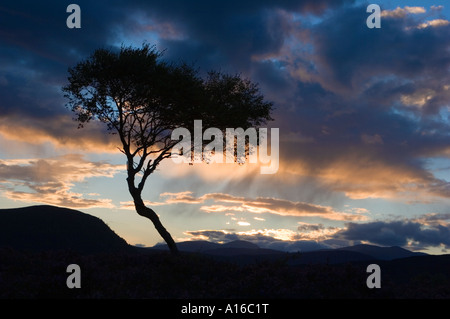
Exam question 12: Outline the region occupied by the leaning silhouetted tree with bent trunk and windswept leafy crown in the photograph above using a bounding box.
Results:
[63,44,272,253]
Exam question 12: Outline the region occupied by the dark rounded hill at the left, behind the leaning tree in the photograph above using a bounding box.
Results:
[0,206,129,253]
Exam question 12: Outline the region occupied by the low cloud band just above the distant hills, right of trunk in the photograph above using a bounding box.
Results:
[185,213,450,251]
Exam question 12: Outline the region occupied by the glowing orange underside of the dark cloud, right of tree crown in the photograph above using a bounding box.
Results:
[277,143,450,202]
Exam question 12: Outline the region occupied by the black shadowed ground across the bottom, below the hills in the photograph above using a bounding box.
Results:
[0,248,450,299]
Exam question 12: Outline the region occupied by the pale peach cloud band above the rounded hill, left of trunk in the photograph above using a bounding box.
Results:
[0,154,123,208]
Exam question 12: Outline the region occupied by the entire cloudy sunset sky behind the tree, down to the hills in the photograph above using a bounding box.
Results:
[0,0,450,254]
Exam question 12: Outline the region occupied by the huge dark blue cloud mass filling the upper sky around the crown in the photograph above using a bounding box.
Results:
[0,0,450,202]
